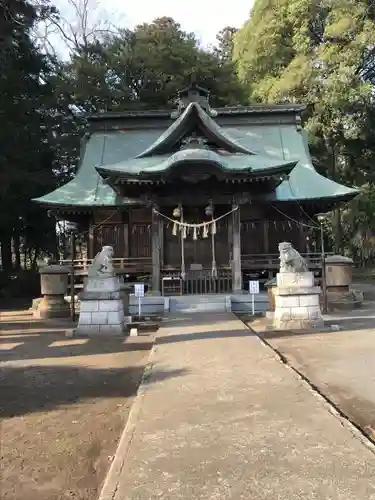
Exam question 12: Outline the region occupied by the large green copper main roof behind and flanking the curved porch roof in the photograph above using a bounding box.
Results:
[35,104,358,209]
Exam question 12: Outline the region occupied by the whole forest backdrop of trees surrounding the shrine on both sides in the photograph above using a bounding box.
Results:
[0,0,375,296]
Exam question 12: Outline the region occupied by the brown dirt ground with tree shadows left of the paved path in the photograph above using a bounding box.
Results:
[0,311,153,500]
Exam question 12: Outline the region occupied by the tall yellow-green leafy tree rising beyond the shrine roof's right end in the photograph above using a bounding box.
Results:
[234,0,375,256]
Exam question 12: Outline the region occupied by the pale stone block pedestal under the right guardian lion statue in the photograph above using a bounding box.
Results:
[273,272,324,330]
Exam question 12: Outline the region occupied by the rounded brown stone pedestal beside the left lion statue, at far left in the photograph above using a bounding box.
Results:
[33,265,70,319]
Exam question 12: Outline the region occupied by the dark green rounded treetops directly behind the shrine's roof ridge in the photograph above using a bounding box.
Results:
[61,17,244,111]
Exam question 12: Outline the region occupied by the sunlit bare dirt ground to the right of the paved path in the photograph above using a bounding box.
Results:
[244,302,375,443]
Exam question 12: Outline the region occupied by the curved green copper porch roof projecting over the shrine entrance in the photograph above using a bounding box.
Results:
[96,148,297,178]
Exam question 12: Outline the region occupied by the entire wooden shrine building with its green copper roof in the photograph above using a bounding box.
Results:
[35,85,357,294]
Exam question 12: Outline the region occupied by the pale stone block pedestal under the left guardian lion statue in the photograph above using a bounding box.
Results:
[74,274,129,337]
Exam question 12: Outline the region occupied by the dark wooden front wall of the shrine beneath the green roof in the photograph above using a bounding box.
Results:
[77,205,321,294]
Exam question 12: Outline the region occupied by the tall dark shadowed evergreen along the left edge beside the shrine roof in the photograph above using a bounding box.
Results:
[0,0,70,272]
